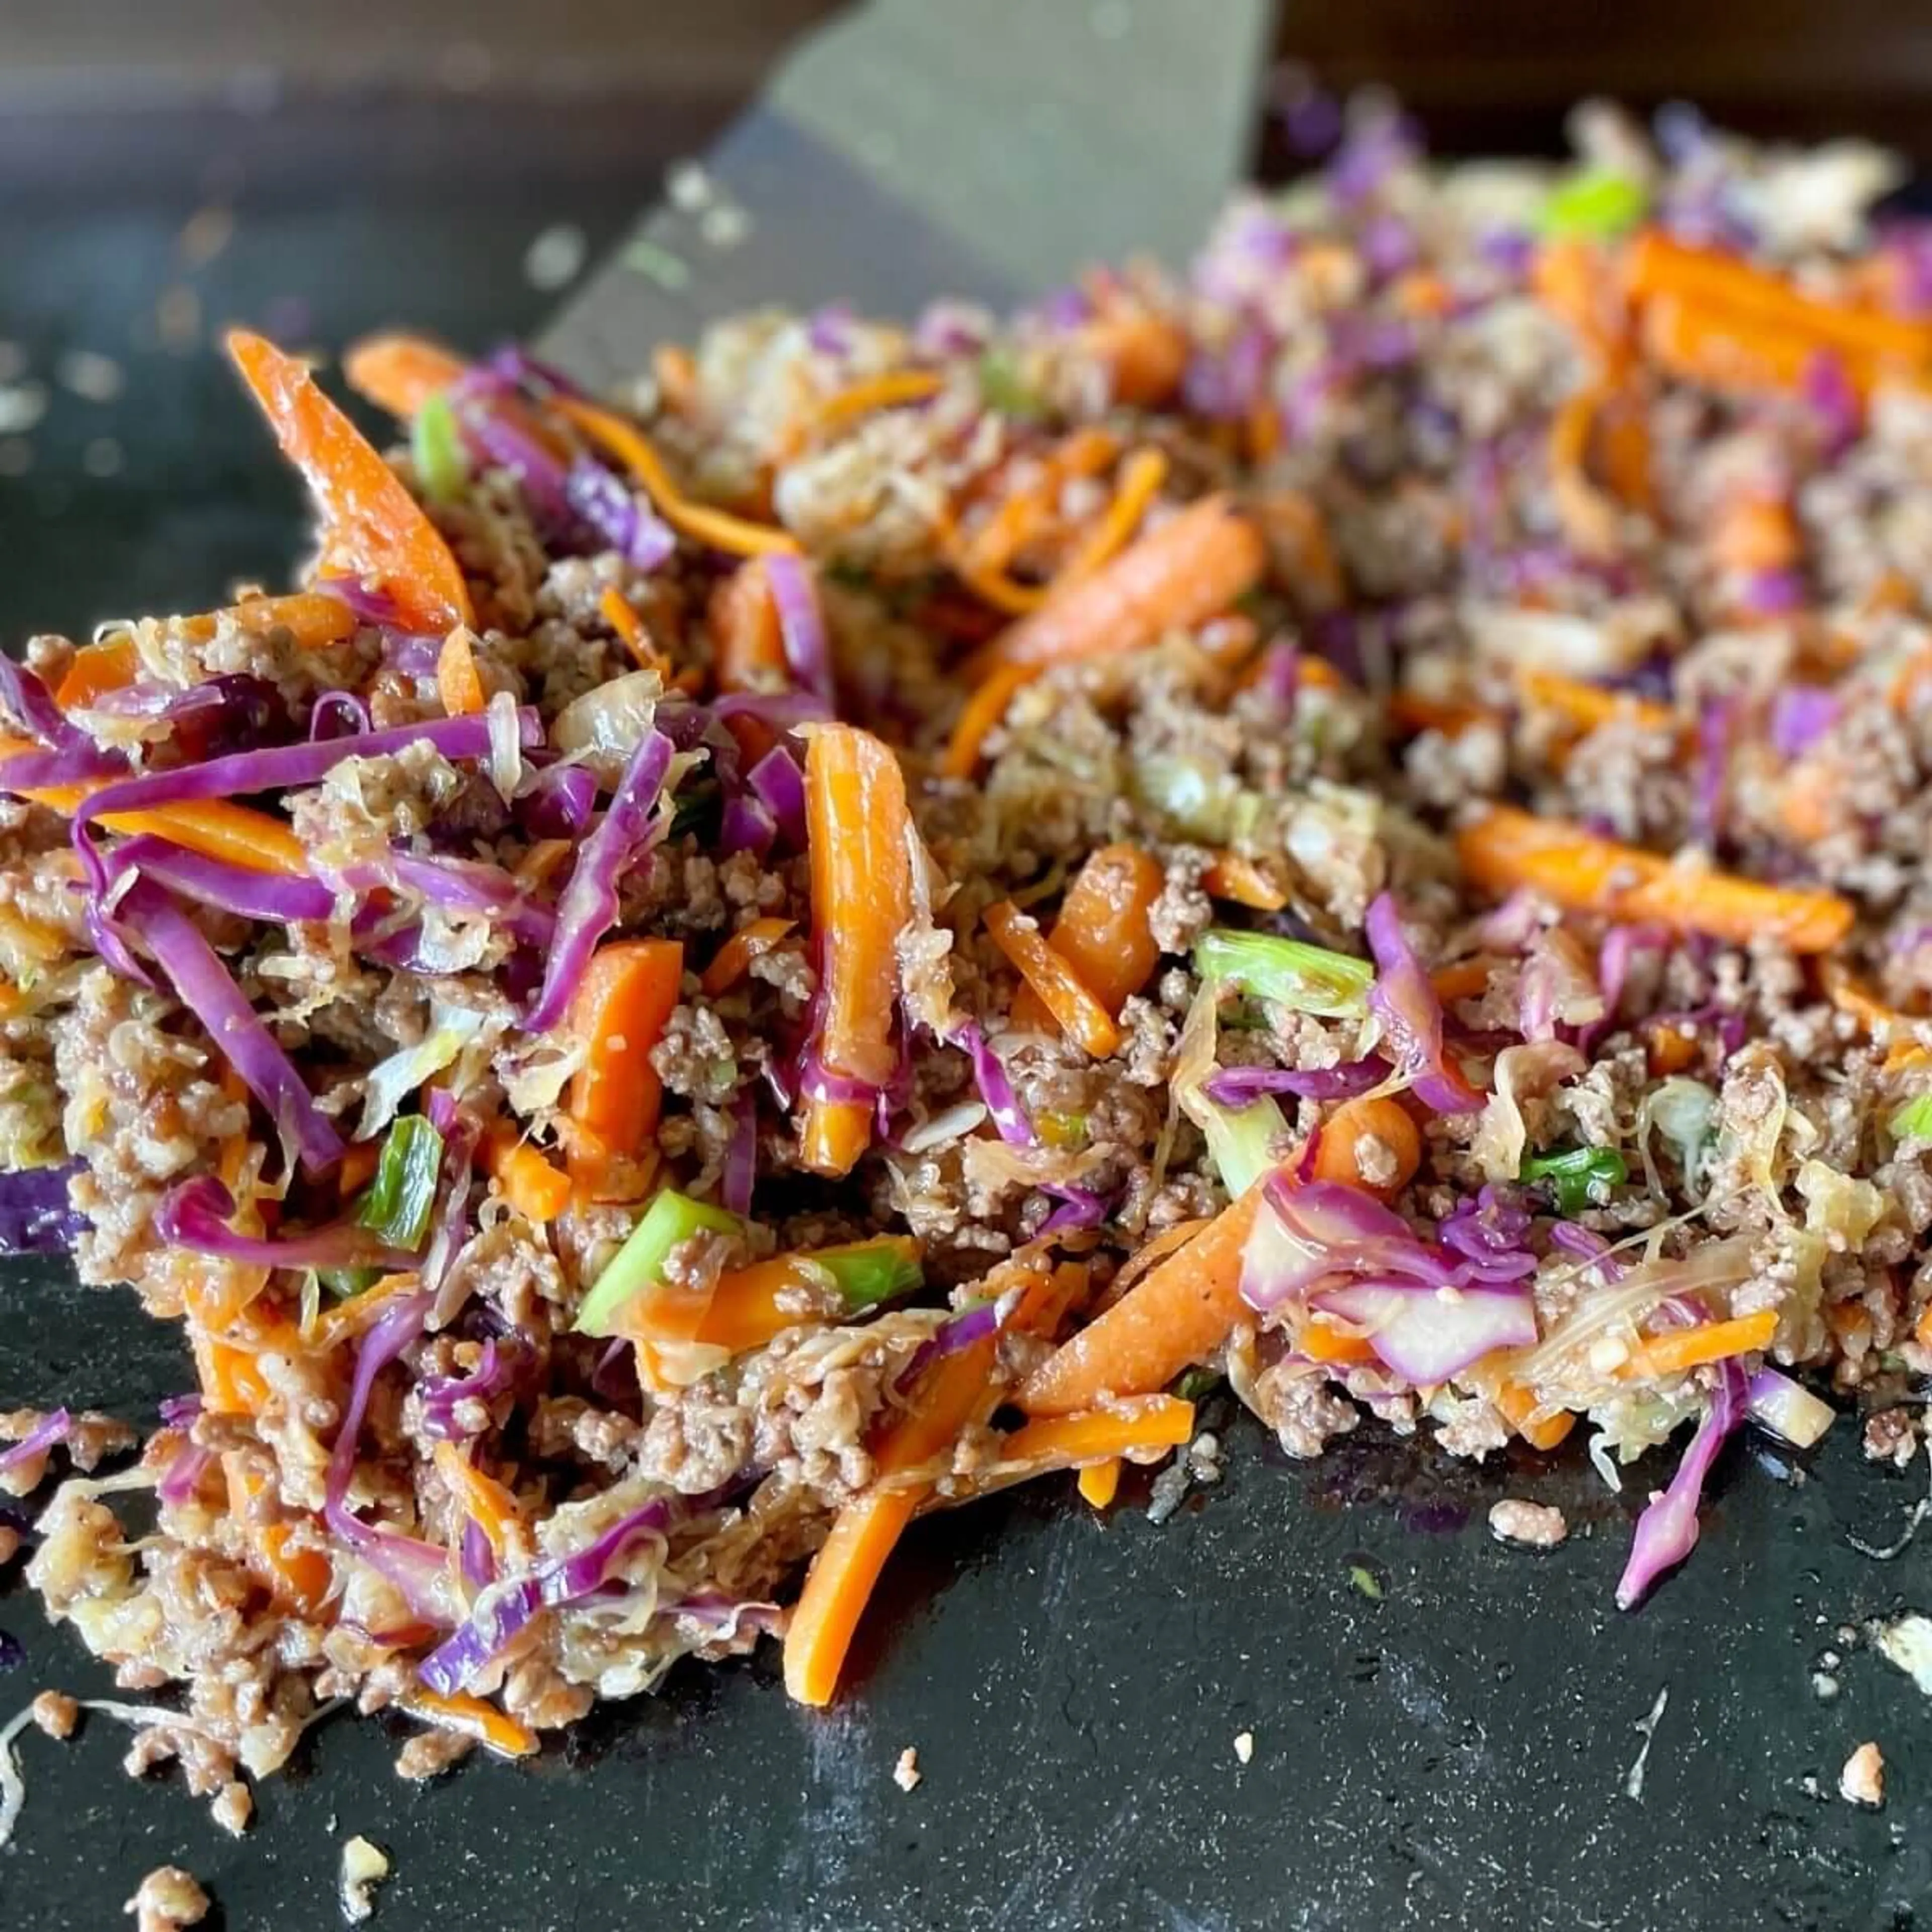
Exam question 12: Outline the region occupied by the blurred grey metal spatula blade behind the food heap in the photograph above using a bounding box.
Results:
[537,0,1273,390]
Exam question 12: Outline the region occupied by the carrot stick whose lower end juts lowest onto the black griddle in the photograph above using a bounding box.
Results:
[784,1339,993,1704]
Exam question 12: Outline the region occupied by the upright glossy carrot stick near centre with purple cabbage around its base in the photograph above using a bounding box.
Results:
[800,725,912,1175]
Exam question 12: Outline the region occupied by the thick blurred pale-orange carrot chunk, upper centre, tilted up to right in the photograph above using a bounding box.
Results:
[980,497,1267,670]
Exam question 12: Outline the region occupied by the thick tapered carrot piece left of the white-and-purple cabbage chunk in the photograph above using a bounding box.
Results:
[1018,1182,1262,1416]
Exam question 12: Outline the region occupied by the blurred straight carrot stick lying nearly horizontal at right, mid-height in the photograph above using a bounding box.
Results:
[1457,806,1853,952]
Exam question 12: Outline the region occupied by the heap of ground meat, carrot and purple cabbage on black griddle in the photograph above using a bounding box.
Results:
[0,94,1932,1808]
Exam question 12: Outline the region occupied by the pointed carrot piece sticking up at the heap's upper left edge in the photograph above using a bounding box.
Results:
[228,329,471,630]
